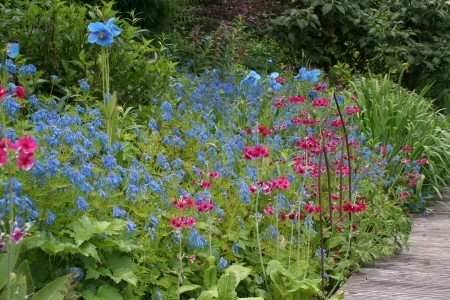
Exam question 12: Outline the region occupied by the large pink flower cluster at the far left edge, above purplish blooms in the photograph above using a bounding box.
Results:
[0,136,37,171]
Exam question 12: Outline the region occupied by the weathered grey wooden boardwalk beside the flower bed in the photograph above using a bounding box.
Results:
[340,189,450,300]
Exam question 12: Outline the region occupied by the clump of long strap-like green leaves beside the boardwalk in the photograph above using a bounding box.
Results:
[351,76,450,210]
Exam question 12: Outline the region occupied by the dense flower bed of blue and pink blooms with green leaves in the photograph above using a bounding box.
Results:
[0,1,448,299]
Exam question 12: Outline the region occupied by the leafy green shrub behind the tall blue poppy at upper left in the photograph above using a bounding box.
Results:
[0,0,176,105]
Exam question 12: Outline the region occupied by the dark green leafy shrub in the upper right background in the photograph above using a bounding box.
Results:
[268,0,450,106]
